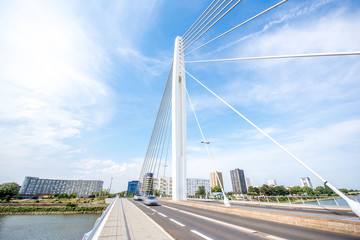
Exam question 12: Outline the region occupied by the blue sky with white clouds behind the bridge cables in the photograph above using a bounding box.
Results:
[0,0,360,191]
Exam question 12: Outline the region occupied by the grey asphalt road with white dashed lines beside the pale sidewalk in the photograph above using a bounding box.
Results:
[131,200,358,240]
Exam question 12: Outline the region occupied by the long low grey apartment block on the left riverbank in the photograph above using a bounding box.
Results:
[20,177,104,197]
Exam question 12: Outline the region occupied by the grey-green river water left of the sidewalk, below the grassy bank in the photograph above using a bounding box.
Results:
[0,214,101,240]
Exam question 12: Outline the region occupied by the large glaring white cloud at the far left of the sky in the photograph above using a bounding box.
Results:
[0,1,112,171]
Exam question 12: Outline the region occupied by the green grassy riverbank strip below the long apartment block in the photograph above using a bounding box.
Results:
[0,198,108,215]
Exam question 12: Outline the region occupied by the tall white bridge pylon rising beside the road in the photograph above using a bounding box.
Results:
[171,37,186,201]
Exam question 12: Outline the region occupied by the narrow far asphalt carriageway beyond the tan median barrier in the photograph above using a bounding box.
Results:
[188,199,358,218]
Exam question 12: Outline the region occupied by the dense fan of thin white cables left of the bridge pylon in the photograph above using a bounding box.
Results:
[139,66,173,189]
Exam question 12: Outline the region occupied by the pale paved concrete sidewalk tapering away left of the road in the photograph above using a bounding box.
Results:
[93,198,173,240]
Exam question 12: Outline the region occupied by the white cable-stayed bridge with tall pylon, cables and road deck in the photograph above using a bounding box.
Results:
[86,0,360,239]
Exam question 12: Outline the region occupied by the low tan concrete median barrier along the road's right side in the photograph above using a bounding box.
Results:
[160,199,360,236]
